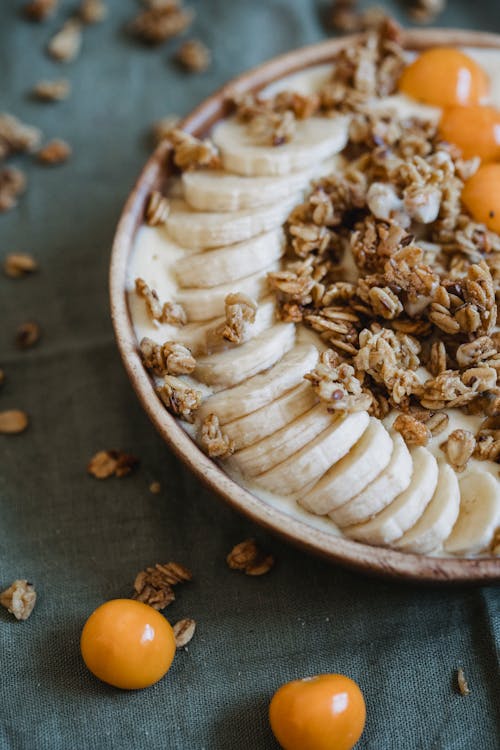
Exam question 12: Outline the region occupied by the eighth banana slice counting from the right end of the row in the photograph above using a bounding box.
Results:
[224,383,318,451]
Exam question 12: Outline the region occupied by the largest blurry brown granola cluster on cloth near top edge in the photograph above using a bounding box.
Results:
[129,0,195,44]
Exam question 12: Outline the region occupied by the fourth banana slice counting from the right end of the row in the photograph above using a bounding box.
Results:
[330,433,413,528]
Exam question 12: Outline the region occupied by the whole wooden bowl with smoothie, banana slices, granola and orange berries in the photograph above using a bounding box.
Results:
[110,23,500,581]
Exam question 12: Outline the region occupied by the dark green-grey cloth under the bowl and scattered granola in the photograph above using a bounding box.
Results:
[0,0,500,750]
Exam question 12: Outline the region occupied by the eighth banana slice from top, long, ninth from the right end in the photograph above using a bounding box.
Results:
[197,344,318,424]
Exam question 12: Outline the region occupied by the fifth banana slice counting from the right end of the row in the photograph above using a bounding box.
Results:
[299,419,392,516]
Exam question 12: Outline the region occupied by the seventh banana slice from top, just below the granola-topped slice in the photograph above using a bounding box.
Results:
[193,323,295,389]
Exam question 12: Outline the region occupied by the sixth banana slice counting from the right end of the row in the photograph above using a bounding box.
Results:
[255,411,369,495]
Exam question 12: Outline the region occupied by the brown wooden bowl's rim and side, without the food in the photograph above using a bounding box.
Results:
[110,29,500,582]
